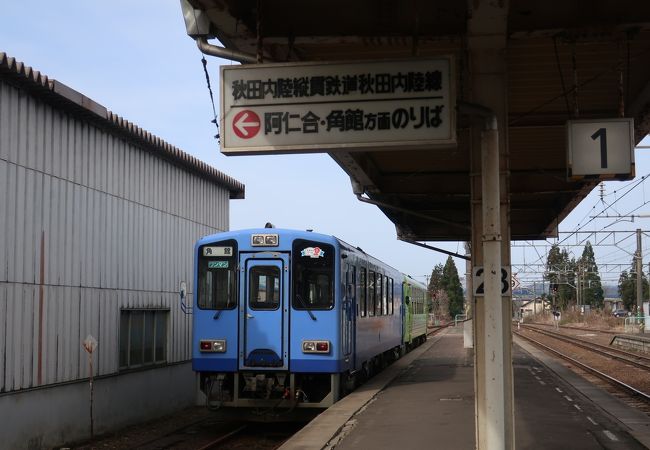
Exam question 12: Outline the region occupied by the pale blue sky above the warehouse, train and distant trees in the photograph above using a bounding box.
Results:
[0,0,650,288]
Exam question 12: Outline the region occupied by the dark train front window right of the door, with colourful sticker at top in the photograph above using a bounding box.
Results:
[292,239,334,309]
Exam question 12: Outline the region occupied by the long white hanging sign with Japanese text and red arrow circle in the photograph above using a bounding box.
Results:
[221,58,456,155]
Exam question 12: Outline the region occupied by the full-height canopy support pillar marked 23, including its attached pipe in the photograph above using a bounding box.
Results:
[468,0,515,450]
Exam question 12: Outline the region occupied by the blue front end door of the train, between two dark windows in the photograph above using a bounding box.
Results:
[239,253,289,370]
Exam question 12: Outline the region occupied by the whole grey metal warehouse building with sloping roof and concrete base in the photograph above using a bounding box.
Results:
[0,53,244,448]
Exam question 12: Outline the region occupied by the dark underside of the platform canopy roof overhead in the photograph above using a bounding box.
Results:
[181,0,650,241]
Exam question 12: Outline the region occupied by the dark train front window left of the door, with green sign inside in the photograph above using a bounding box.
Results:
[197,240,237,309]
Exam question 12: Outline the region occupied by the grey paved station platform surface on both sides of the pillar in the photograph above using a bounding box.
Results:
[280,327,650,450]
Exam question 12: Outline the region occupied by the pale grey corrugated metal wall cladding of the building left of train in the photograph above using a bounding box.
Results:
[0,81,229,392]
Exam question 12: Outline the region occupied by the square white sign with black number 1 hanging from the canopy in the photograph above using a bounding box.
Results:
[567,119,634,180]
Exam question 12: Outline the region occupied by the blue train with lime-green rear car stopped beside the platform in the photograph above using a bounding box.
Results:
[192,228,428,413]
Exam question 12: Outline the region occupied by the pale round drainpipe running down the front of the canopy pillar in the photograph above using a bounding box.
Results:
[479,117,510,449]
